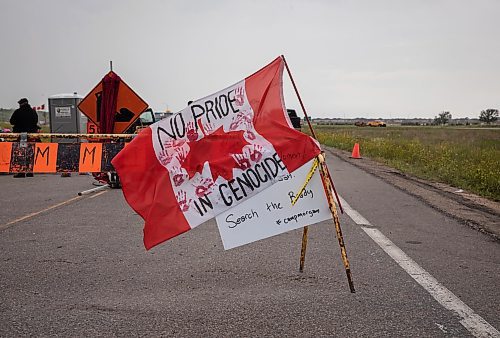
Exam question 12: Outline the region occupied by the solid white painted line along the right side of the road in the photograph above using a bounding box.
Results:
[339,197,500,337]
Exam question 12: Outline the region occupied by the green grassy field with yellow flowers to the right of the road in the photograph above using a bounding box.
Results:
[314,126,500,201]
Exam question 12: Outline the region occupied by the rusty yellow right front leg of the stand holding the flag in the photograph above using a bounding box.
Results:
[318,153,356,293]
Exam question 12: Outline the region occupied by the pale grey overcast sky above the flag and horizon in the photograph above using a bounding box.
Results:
[0,0,500,118]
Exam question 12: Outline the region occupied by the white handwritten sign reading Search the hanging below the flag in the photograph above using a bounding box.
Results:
[216,160,331,250]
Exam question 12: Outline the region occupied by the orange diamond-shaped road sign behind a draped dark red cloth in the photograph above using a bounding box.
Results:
[78,71,148,134]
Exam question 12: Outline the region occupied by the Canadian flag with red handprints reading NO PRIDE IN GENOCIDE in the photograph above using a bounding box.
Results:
[112,57,320,249]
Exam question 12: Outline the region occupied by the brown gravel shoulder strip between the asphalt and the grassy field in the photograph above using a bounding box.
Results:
[324,147,500,241]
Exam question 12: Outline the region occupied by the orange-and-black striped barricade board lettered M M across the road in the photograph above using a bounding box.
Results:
[0,142,125,173]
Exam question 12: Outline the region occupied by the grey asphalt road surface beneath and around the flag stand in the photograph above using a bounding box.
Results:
[0,157,500,337]
